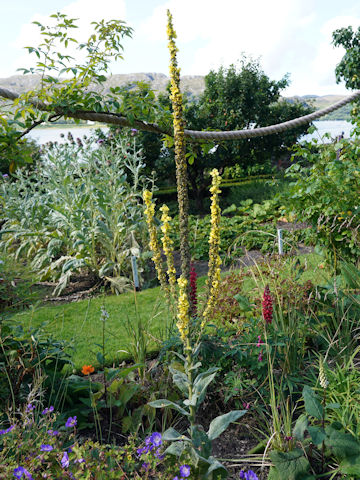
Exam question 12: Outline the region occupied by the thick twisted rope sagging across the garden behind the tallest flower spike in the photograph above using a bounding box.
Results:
[0,87,360,141]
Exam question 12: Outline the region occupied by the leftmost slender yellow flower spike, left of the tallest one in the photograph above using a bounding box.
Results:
[143,190,170,300]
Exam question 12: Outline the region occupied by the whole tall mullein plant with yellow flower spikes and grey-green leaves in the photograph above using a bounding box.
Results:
[144,12,246,480]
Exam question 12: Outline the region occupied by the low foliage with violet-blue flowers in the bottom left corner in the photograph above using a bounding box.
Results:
[0,400,178,480]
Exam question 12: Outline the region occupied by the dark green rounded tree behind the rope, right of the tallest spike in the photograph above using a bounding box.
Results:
[185,57,312,208]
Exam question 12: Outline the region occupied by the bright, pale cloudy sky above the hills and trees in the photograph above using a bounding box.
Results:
[0,0,360,96]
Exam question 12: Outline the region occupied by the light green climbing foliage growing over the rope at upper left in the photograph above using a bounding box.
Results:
[0,13,168,172]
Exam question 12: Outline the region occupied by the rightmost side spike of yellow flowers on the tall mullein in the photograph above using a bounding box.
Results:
[201,168,221,328]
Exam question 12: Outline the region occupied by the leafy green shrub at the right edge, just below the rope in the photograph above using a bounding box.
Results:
[282,124,360,270]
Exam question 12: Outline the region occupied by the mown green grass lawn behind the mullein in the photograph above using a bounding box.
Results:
[9,254,328,370]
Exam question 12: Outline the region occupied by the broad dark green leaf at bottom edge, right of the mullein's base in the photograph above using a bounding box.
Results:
[270,448,311,480]
